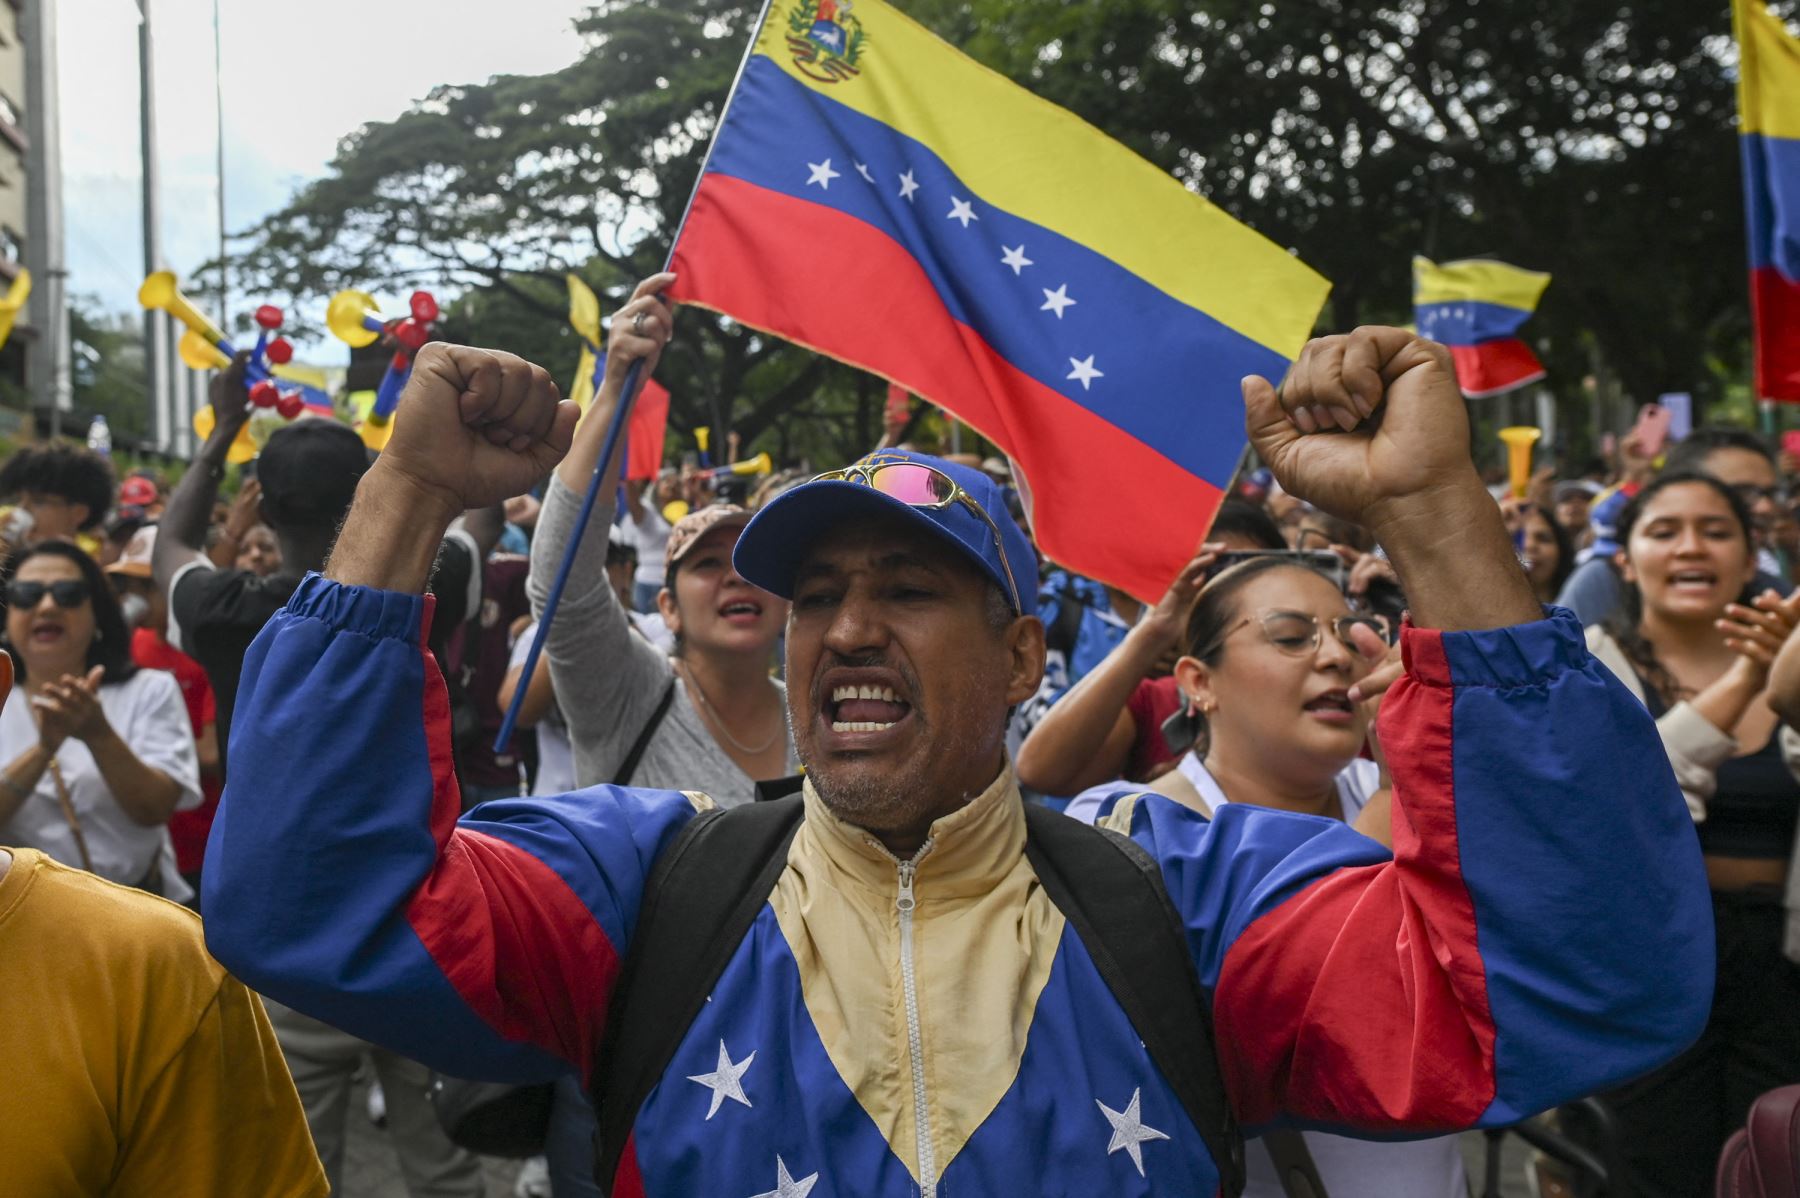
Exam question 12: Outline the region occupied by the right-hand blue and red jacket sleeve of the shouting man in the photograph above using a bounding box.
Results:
[1118,613,1714,1131]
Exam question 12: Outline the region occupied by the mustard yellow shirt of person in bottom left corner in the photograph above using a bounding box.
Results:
[0,849,326,1198]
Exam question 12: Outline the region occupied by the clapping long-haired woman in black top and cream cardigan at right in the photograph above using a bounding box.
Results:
[1571,471,1800,1196]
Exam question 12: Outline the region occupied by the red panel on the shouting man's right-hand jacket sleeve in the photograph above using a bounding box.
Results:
[1215,630,1496,1130]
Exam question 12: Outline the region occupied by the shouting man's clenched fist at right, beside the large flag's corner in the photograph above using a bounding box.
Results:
[1244,327,1481,529]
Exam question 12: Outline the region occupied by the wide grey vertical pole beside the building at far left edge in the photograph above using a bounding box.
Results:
[20,0,70,437]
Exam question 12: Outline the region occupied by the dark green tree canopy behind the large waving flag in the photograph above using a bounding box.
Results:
[234,0,1795,457]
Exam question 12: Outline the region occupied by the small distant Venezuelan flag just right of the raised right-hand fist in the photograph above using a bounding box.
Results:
[1413,257,1550,399]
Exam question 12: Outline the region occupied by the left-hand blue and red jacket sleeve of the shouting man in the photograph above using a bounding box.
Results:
[203,576,695,1081]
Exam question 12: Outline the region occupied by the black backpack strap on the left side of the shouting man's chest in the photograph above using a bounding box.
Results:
[590,795,805,1194]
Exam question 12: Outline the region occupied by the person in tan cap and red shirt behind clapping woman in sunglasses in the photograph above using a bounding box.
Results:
[106,528,221,894]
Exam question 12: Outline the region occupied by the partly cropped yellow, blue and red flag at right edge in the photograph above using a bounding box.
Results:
[1732,0,1800,399]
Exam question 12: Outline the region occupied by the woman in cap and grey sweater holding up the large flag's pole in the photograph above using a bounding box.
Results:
[527,275,796,806]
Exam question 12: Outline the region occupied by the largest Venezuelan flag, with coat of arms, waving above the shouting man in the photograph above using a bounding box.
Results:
[671,0,1328,599]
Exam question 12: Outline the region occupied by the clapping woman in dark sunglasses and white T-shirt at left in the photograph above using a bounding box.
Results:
[0,541,200,901]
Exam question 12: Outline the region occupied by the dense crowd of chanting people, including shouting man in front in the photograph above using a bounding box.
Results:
[0,277,1800,1198]
